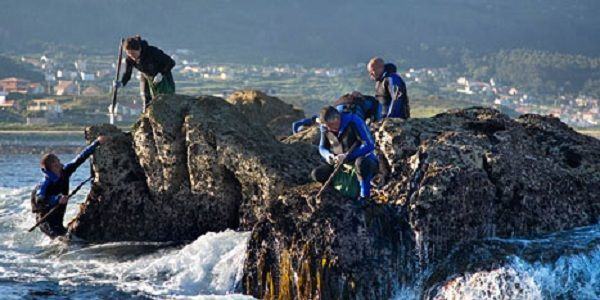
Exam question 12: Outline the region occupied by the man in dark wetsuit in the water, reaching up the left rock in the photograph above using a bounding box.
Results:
[31,136,110,239]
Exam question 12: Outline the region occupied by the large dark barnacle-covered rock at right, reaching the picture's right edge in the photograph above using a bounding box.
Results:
[376,108,600,263]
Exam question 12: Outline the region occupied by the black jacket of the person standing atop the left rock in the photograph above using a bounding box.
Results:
[121,40,175,85]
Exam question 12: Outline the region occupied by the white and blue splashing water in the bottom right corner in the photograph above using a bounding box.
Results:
[436,248,600,299]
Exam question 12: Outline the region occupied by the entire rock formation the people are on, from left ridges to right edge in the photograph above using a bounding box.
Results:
[70,96,600,299]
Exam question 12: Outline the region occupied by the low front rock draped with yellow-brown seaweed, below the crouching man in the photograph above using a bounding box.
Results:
[243,184,417,299]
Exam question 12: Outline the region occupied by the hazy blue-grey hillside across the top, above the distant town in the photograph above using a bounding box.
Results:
[0,0,600,65]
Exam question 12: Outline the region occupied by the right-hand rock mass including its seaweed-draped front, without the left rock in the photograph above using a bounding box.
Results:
[244,108,600,299]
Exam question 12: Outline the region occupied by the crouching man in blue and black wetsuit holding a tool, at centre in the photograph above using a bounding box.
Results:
[311,106,378,205]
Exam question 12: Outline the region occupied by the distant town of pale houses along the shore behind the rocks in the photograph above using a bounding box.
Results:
[0,49,600,128]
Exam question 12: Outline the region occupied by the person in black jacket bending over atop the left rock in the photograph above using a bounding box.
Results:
[113,35,175,111]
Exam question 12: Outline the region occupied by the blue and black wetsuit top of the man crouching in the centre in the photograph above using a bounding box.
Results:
[319,113,375,163]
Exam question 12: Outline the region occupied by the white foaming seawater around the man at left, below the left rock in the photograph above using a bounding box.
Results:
[0,155,251,299]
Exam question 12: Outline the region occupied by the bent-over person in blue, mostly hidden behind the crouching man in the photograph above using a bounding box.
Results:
[334,92,381,123]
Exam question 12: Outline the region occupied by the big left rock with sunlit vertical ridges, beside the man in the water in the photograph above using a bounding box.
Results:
[71,96,318,241]
